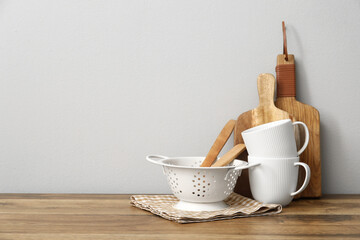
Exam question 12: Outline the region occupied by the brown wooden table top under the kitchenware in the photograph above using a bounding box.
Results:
[0,194,360,240]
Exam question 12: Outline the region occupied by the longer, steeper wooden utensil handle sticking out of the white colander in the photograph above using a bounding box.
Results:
[200,119,236,167]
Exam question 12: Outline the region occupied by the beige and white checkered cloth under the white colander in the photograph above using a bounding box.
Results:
[130,193,282,223]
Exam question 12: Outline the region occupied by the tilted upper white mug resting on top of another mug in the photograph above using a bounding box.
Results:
[241,119,309,158]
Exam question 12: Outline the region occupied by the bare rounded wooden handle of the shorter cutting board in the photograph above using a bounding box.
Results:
[257,73,275,107]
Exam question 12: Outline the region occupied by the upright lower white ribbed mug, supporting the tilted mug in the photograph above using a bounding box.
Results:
[248,156,310,206]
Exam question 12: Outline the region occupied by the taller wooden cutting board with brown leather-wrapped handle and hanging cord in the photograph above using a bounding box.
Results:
[275,22,321,197]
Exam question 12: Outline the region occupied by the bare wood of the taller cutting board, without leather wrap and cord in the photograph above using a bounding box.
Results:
[275,54,321,197]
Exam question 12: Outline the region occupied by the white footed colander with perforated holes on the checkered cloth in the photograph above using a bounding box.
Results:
[146,155,258,211]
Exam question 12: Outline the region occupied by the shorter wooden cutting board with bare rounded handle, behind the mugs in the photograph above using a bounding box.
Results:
[234,73,295,197]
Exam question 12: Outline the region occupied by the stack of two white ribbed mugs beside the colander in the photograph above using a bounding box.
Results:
[241,119,310,206]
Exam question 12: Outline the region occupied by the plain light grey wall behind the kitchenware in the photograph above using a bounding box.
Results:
[0,0,360,193]
